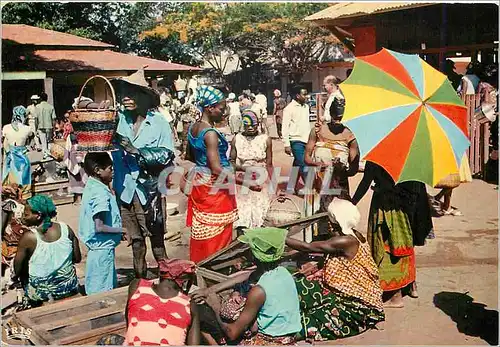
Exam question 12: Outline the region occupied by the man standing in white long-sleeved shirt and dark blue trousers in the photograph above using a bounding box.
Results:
[282,85,311,192]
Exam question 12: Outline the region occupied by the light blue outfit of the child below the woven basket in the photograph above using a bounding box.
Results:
[78,177,122,295]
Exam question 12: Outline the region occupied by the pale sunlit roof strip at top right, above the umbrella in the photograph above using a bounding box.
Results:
[305,2,433,21]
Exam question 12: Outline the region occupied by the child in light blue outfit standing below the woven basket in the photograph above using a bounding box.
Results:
[78,152,125,295]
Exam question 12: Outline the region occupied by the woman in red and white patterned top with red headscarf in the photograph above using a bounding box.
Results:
[125,259,200,346]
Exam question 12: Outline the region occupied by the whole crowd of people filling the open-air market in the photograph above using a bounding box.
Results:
[2,59,496,345]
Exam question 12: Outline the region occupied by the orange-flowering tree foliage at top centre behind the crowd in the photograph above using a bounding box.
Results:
[141,2,344,81]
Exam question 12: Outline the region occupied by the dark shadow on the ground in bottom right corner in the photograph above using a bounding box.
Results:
[433,292,498,345]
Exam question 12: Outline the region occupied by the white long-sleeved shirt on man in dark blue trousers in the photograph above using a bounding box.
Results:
[282,100,311,147]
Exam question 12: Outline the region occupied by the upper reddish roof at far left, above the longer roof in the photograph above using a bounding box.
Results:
[2,24,114,48]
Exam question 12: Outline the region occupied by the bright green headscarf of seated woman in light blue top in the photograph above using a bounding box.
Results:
[238,228,288,263]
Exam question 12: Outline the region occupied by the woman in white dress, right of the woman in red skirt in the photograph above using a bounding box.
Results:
[231,110,273,228]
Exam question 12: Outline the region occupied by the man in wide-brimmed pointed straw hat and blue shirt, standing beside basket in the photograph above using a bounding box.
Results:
[111,68,174,278]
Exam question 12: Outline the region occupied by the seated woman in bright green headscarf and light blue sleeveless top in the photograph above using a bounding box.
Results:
[202,228,301,346]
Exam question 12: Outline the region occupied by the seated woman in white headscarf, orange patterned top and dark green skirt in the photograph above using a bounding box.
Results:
[286,198,385,340]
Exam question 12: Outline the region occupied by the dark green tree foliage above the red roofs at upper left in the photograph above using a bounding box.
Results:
[2,2,199,64]
